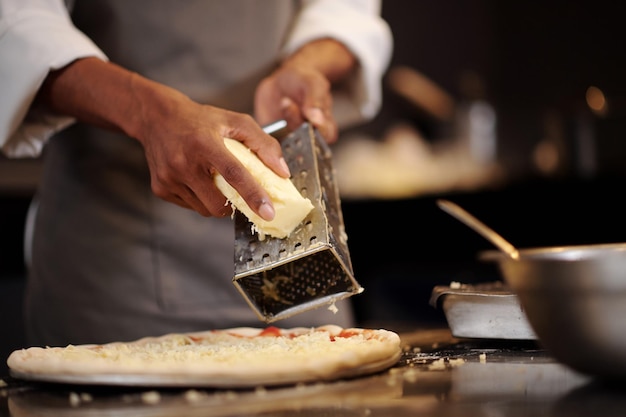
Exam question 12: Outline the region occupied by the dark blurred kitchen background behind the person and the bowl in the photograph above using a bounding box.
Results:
[0,0,626,357]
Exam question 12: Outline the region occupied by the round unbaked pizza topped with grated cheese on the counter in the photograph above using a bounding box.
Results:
[7,325,401,388]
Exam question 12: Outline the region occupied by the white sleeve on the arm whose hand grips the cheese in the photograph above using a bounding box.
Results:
[0,0,107,157]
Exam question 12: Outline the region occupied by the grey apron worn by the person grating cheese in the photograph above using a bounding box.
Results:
[26,0,353,345]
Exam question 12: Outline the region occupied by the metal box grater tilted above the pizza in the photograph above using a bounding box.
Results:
[233,123,363,323]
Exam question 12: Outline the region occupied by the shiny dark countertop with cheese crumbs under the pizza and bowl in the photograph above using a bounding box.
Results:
[0,329,626,417]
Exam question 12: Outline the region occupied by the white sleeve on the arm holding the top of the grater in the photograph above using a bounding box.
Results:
[283,0,393,126]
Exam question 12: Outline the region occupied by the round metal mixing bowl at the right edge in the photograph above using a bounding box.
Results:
[481,243,626,379]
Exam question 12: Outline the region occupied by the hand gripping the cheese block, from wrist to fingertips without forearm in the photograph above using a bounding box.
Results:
[136,88,290,220]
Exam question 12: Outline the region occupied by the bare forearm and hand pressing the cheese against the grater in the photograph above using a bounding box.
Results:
[38,58,289,220]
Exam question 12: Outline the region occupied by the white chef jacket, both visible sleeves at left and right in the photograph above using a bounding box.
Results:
[0,0,392,157]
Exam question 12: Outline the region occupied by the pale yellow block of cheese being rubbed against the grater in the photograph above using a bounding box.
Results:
[215,138,313,239]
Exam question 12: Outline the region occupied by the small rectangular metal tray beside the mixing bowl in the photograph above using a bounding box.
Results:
[430,281,537,340]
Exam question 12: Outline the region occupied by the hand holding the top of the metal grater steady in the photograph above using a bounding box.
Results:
[254,39,356,143]
